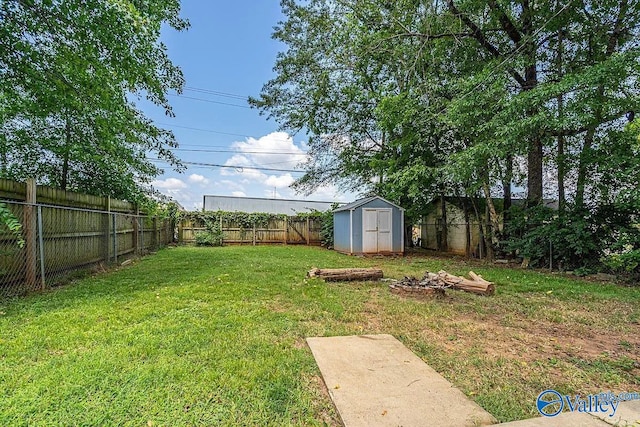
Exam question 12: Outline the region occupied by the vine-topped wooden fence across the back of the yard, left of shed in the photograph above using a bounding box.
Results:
[178,216,322,246]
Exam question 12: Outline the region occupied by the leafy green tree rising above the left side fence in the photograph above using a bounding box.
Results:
[0,0,188,201]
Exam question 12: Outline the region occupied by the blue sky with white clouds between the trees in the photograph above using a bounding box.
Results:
[140,0,353,210]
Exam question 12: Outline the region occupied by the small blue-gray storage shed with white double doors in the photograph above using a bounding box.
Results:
[333,196,404,255]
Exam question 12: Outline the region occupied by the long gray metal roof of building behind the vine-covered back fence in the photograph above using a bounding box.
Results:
[203,195,340,216]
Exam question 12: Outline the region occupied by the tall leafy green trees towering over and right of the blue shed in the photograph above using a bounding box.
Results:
[252,0,640,268]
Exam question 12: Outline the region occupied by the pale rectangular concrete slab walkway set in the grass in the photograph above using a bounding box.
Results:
[307,335,496,427]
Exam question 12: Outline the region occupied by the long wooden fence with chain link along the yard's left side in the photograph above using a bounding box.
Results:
[0,201,174,298]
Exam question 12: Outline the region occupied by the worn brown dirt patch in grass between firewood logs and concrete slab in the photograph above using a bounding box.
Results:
[362,294,640,398]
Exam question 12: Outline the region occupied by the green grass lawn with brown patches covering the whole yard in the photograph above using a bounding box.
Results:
[0,246,640,426]
